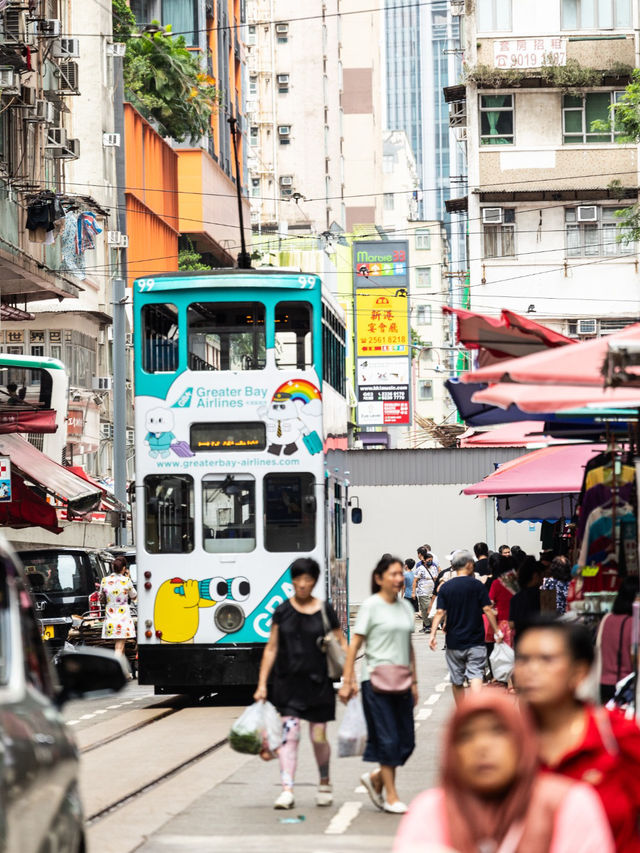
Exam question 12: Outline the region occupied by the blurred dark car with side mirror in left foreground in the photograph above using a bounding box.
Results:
[0,539,127,853]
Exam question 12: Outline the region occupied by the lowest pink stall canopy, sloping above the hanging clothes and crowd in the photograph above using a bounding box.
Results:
[463,444,606,497]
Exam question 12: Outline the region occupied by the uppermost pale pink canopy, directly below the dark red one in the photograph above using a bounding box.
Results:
[460,323,640,386]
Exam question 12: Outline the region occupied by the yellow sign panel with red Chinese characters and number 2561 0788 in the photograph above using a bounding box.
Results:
[355,288,409,358]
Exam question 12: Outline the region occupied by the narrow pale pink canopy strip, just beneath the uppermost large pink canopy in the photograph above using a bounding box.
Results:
[471,384,640,415]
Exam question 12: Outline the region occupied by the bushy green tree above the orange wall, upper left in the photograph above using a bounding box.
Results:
[124,27,219,142]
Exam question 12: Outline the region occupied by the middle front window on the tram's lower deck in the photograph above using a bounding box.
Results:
[202,474,256,554]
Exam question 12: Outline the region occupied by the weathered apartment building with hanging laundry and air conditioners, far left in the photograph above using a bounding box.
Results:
[0,0,121,476]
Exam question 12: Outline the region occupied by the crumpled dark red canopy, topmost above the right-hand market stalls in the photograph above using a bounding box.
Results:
[442,306,575,359]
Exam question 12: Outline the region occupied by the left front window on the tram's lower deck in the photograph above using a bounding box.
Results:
[144,474,193,554]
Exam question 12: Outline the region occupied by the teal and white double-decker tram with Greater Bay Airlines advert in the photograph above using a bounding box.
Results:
[134,269,348,693]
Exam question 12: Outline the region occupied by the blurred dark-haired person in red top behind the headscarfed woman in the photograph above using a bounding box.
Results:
[513,617,640,853]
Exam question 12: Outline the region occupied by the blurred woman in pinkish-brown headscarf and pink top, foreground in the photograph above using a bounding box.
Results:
[393,690,615,853]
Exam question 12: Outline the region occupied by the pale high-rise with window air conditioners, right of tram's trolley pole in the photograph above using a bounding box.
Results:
[245,0,346,234]
